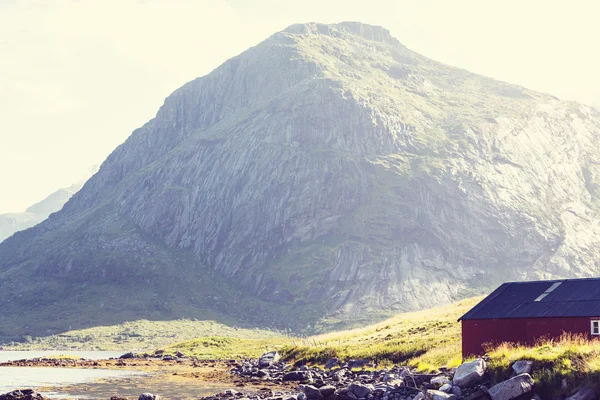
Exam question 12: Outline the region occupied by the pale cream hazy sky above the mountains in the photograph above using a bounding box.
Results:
[0,0,600,213]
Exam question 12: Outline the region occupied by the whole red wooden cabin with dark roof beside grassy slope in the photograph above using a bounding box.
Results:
[459,278,600,358]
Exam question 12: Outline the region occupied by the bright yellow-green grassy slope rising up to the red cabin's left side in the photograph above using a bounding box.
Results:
[281,297,481,371]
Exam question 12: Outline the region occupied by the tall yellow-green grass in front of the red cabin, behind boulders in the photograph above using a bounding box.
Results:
[487,334,600,398]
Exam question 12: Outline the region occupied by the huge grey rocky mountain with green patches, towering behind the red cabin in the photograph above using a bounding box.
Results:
[0,22,600,335]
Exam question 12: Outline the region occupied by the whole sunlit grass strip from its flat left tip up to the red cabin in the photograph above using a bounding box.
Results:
[165,297,481,370]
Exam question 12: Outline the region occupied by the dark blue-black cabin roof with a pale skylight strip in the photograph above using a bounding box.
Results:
[459,278,600,321]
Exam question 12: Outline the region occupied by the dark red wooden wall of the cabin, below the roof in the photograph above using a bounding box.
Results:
[461,317,600,358]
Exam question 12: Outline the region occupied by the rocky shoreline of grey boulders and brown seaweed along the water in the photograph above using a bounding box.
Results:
[0,352,598,400]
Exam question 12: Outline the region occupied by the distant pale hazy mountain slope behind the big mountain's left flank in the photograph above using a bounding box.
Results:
[0,167,98,242]
